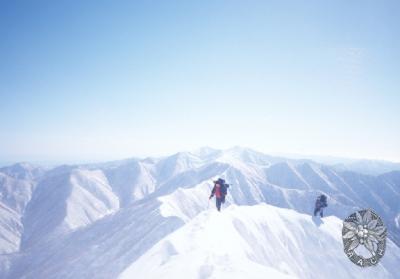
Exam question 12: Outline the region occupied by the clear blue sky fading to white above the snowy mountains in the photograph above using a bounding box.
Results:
[0,0,400,162]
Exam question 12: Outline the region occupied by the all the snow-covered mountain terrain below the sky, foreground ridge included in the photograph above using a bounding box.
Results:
[0,148,400,278]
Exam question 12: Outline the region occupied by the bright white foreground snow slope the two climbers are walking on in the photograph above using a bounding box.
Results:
[119,204,400,279]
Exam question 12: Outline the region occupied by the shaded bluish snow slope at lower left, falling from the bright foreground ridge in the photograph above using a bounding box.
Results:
[2,199,184,279]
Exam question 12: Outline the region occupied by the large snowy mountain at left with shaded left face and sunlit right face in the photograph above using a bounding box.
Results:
[22,168,119,248]
